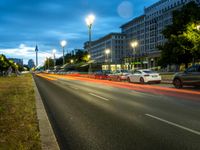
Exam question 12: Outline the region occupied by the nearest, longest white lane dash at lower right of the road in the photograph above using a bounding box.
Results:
[145,114,200,135]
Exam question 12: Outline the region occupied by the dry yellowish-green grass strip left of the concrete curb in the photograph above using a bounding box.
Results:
[0,74,41,150]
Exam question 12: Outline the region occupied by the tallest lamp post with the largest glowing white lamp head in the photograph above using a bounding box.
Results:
[85,15,95,72]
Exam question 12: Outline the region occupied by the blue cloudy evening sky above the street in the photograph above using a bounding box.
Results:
[0,0,158,64]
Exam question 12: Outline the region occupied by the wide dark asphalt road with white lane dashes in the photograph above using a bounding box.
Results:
[34,76,200,150]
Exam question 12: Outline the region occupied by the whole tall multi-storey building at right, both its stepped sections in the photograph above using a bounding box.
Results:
[121,0,200,68]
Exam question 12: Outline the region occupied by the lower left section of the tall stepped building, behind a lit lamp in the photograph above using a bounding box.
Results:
[121,15,147,68]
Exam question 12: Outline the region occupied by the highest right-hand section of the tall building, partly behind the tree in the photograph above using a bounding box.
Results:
[144,0,200,68]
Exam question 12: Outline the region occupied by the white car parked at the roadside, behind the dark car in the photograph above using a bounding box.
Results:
[127,69,161,84]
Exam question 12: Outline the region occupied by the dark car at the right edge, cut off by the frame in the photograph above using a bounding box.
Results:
[173,65,200,88]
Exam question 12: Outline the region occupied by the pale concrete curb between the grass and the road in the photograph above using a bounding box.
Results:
[33,79,60,150]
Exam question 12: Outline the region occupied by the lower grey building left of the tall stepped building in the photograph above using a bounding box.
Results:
[84,33,126,68]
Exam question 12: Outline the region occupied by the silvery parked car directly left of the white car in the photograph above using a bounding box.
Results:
[108,70,130,81]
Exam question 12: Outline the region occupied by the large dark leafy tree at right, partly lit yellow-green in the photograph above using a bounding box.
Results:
[158,2,200,68]
